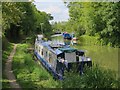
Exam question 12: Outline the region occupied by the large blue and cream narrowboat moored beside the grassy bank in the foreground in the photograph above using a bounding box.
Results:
[34,35,92,80]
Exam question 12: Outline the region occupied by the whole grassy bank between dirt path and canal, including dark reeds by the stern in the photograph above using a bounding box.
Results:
[13,44,118,90]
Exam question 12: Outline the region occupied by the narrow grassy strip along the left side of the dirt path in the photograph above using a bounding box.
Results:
[2,43,13,88]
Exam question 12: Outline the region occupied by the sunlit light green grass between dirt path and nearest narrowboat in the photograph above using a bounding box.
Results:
[13,44,60,89]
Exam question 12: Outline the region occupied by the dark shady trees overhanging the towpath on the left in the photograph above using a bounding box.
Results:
[2,2,53,42]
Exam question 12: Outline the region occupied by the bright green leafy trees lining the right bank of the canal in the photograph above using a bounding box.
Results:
[53,2,120,47]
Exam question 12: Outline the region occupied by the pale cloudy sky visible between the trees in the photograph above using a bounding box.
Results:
[34,0,69,22]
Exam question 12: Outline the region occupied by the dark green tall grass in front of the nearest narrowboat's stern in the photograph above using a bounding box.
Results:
[63,65,118,88]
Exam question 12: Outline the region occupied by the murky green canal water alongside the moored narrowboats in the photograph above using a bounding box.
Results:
[52,35,118,72]
